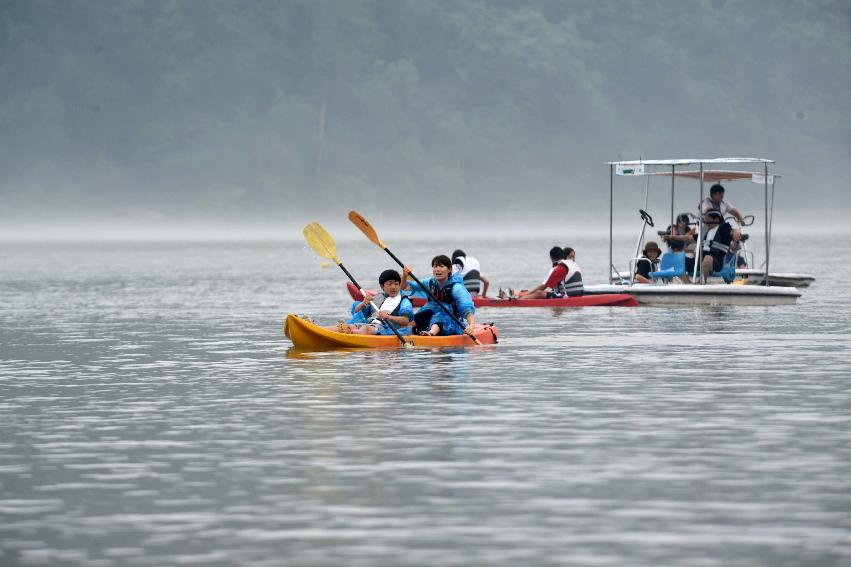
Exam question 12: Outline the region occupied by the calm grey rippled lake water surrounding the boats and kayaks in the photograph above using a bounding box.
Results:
[0,235,851,567]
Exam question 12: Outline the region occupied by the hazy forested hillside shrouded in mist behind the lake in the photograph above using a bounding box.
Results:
[0,0,851,218]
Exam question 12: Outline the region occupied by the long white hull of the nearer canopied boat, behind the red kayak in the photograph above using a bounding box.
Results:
[585,284,801,305]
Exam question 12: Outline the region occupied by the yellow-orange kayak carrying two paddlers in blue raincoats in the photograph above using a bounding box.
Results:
[284,314,498,348]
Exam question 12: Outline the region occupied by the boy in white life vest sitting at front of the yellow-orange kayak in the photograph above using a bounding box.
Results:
[342,270,414,335]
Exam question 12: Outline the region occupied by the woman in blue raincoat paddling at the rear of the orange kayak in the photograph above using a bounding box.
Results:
[402,254,476,336]
